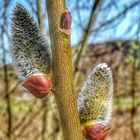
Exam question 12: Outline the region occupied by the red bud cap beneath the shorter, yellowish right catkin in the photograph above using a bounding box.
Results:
[83,124,110,140]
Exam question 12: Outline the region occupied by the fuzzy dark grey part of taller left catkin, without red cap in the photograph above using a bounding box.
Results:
[11,4,51,80]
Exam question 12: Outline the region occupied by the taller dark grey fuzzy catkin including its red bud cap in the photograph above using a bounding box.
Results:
[11,4,52,98]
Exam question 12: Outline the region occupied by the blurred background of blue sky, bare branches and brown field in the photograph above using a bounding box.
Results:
[0,0,140,140]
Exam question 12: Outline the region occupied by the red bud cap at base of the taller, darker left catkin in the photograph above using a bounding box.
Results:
[22,75,52,98]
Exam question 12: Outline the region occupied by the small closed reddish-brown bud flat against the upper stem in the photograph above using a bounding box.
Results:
[60,10,72,35]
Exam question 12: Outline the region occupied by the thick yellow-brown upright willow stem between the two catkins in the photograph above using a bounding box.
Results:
[46,0,83,140]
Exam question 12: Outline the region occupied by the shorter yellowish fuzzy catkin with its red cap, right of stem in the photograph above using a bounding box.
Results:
[77,63,113,139]
